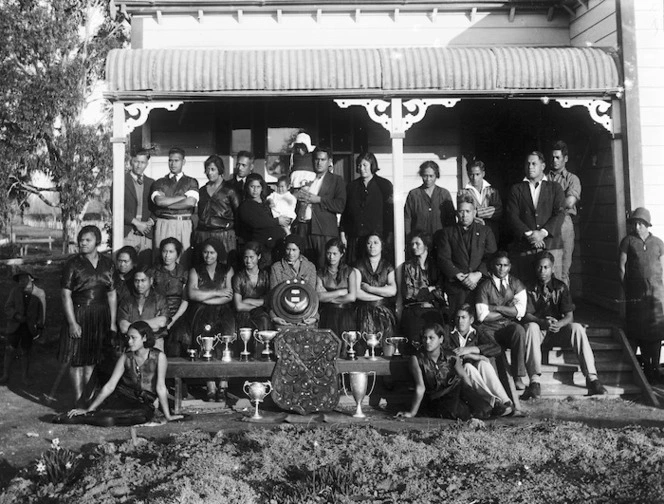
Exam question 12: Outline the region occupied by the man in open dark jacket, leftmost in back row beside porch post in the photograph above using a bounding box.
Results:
[124,149,158,264]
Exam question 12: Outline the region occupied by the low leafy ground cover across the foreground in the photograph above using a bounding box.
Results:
[0,421,664,504]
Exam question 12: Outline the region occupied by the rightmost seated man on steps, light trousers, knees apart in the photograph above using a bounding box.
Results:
[521,252,606,399]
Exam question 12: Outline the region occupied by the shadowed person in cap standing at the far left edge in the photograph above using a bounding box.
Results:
[0,270,46,385]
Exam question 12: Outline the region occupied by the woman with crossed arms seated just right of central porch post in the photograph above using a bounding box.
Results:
[401,231,445,344]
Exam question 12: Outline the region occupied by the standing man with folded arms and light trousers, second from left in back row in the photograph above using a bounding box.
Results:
[150,147,198,266]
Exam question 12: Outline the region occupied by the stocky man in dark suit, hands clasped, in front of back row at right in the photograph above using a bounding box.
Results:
[437,195,496,315]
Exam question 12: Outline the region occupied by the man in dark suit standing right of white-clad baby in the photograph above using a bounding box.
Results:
[295,146,346,268]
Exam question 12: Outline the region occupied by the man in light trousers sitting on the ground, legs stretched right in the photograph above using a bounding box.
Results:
[443,303,514,416]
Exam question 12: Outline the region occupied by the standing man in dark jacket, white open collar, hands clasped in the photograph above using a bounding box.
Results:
[505,151,565,284]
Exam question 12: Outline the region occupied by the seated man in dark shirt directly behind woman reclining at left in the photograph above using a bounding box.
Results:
[117,266,169,352]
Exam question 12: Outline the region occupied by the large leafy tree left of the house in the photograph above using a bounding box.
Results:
[0,0,128,252]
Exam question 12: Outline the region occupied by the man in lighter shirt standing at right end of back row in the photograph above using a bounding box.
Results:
[548,141,581,287]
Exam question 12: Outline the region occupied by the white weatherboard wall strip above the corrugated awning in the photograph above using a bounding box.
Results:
[131,8,570,49]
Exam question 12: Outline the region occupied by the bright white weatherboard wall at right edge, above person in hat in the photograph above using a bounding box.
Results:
[628,0,664,239]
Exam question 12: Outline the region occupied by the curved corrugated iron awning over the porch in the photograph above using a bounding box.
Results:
[106,46,621,99]
